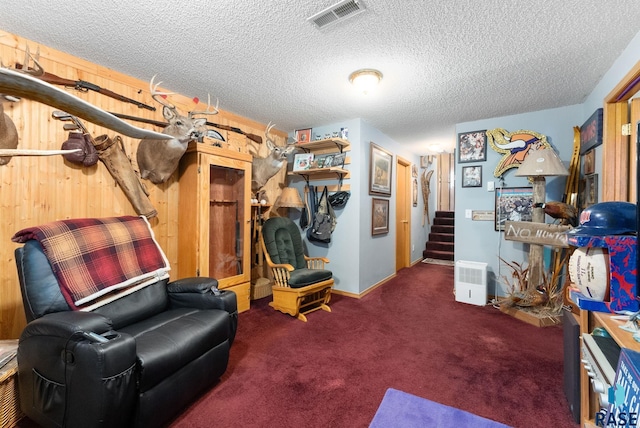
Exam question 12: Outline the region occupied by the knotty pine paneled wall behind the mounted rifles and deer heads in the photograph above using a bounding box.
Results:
[0,30,287,339]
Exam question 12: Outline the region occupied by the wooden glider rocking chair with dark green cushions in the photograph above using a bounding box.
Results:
[260,217,334,322]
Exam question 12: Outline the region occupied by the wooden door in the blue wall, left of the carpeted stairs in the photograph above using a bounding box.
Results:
[396,157,411,272]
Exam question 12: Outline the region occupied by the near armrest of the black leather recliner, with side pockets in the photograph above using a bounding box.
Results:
[18,311,136,426]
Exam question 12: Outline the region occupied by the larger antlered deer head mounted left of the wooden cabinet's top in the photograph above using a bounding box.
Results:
[136,76,218,184]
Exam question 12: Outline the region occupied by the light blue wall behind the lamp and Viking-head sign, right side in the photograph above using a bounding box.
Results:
[455,32,640,296]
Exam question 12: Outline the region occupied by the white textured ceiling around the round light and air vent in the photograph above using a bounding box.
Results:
[0,0,640,154]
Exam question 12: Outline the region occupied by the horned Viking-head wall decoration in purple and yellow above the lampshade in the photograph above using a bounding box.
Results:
[487,128,551,178]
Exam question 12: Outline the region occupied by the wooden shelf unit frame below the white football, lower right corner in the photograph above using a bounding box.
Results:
[580,310,640,428]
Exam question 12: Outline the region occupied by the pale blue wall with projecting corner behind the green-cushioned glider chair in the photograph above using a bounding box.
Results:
[289,119,434,295]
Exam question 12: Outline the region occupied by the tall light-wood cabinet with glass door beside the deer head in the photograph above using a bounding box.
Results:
[178,143,252,312]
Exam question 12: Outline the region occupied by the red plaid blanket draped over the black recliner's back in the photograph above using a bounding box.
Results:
[11,216,170,310]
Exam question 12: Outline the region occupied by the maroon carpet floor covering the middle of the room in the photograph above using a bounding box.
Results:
[171,263,578,428]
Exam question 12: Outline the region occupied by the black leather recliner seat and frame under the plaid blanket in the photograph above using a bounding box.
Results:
[15,240,238,428]
